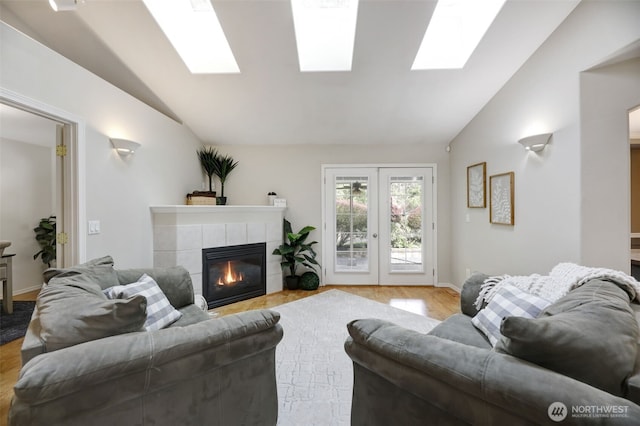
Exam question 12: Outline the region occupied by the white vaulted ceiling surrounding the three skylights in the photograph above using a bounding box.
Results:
[0,0,579,144]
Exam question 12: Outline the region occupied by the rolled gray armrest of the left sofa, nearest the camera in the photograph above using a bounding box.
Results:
[14,310,282,408]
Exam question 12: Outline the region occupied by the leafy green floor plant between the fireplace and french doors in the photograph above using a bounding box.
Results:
[273,219,320,290]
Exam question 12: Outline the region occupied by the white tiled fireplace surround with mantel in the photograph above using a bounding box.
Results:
[151,205,286,294]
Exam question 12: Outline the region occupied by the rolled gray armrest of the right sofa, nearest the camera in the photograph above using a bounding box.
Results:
[345,319,640,424]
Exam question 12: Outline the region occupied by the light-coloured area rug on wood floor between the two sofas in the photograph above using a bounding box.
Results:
[271,290,439,426]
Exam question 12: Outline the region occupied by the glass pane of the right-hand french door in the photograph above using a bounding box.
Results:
[389,176,424,272]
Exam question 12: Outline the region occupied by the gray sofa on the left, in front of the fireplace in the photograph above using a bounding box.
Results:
[8,256,282,426]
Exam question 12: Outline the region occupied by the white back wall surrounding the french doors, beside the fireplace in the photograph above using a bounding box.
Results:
[208,144,451,284]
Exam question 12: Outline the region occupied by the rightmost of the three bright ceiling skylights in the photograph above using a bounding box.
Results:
[411,0,505,70]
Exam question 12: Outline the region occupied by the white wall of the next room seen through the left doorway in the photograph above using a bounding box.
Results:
[0,138,55,294]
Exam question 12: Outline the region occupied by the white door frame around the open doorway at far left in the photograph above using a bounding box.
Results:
[0,87,87,267]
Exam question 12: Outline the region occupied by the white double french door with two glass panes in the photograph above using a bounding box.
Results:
[323,166,436,285]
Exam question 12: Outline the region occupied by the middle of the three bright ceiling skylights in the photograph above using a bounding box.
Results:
[291,0,358,71]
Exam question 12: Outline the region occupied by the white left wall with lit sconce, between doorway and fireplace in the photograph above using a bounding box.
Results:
[0,23,202,268]
